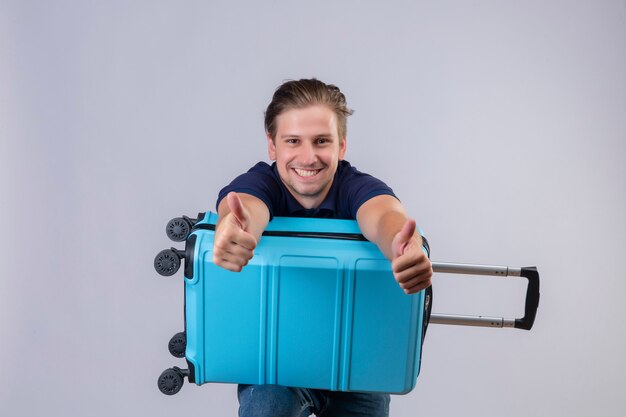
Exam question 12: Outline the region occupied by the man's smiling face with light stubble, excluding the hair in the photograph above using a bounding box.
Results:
[267,105,346,208]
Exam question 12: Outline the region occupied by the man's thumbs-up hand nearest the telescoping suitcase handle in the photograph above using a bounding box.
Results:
[391,219,433,294]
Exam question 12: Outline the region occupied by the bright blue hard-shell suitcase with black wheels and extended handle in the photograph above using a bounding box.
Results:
[154,212,538,395]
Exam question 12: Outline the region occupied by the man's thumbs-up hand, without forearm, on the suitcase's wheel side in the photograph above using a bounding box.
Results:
[213,192,258,272]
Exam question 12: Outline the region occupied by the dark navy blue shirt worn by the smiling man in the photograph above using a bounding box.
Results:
[217,161,397,219]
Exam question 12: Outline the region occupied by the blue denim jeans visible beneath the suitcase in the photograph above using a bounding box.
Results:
[237,385,390,417]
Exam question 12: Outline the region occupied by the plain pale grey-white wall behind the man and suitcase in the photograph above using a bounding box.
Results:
[0,0,626,417]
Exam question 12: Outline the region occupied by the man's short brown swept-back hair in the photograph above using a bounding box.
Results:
[265,78,353,141]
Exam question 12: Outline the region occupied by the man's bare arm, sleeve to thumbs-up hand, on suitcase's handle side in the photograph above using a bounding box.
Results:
[356,195,433,294]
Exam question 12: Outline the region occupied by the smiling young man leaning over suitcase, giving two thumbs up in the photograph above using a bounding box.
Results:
[213,79,432,417]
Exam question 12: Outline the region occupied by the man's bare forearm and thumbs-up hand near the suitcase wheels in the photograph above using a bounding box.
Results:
[213,192,270,272]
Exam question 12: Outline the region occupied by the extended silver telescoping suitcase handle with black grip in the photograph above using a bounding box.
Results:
[430,262,539,330]
